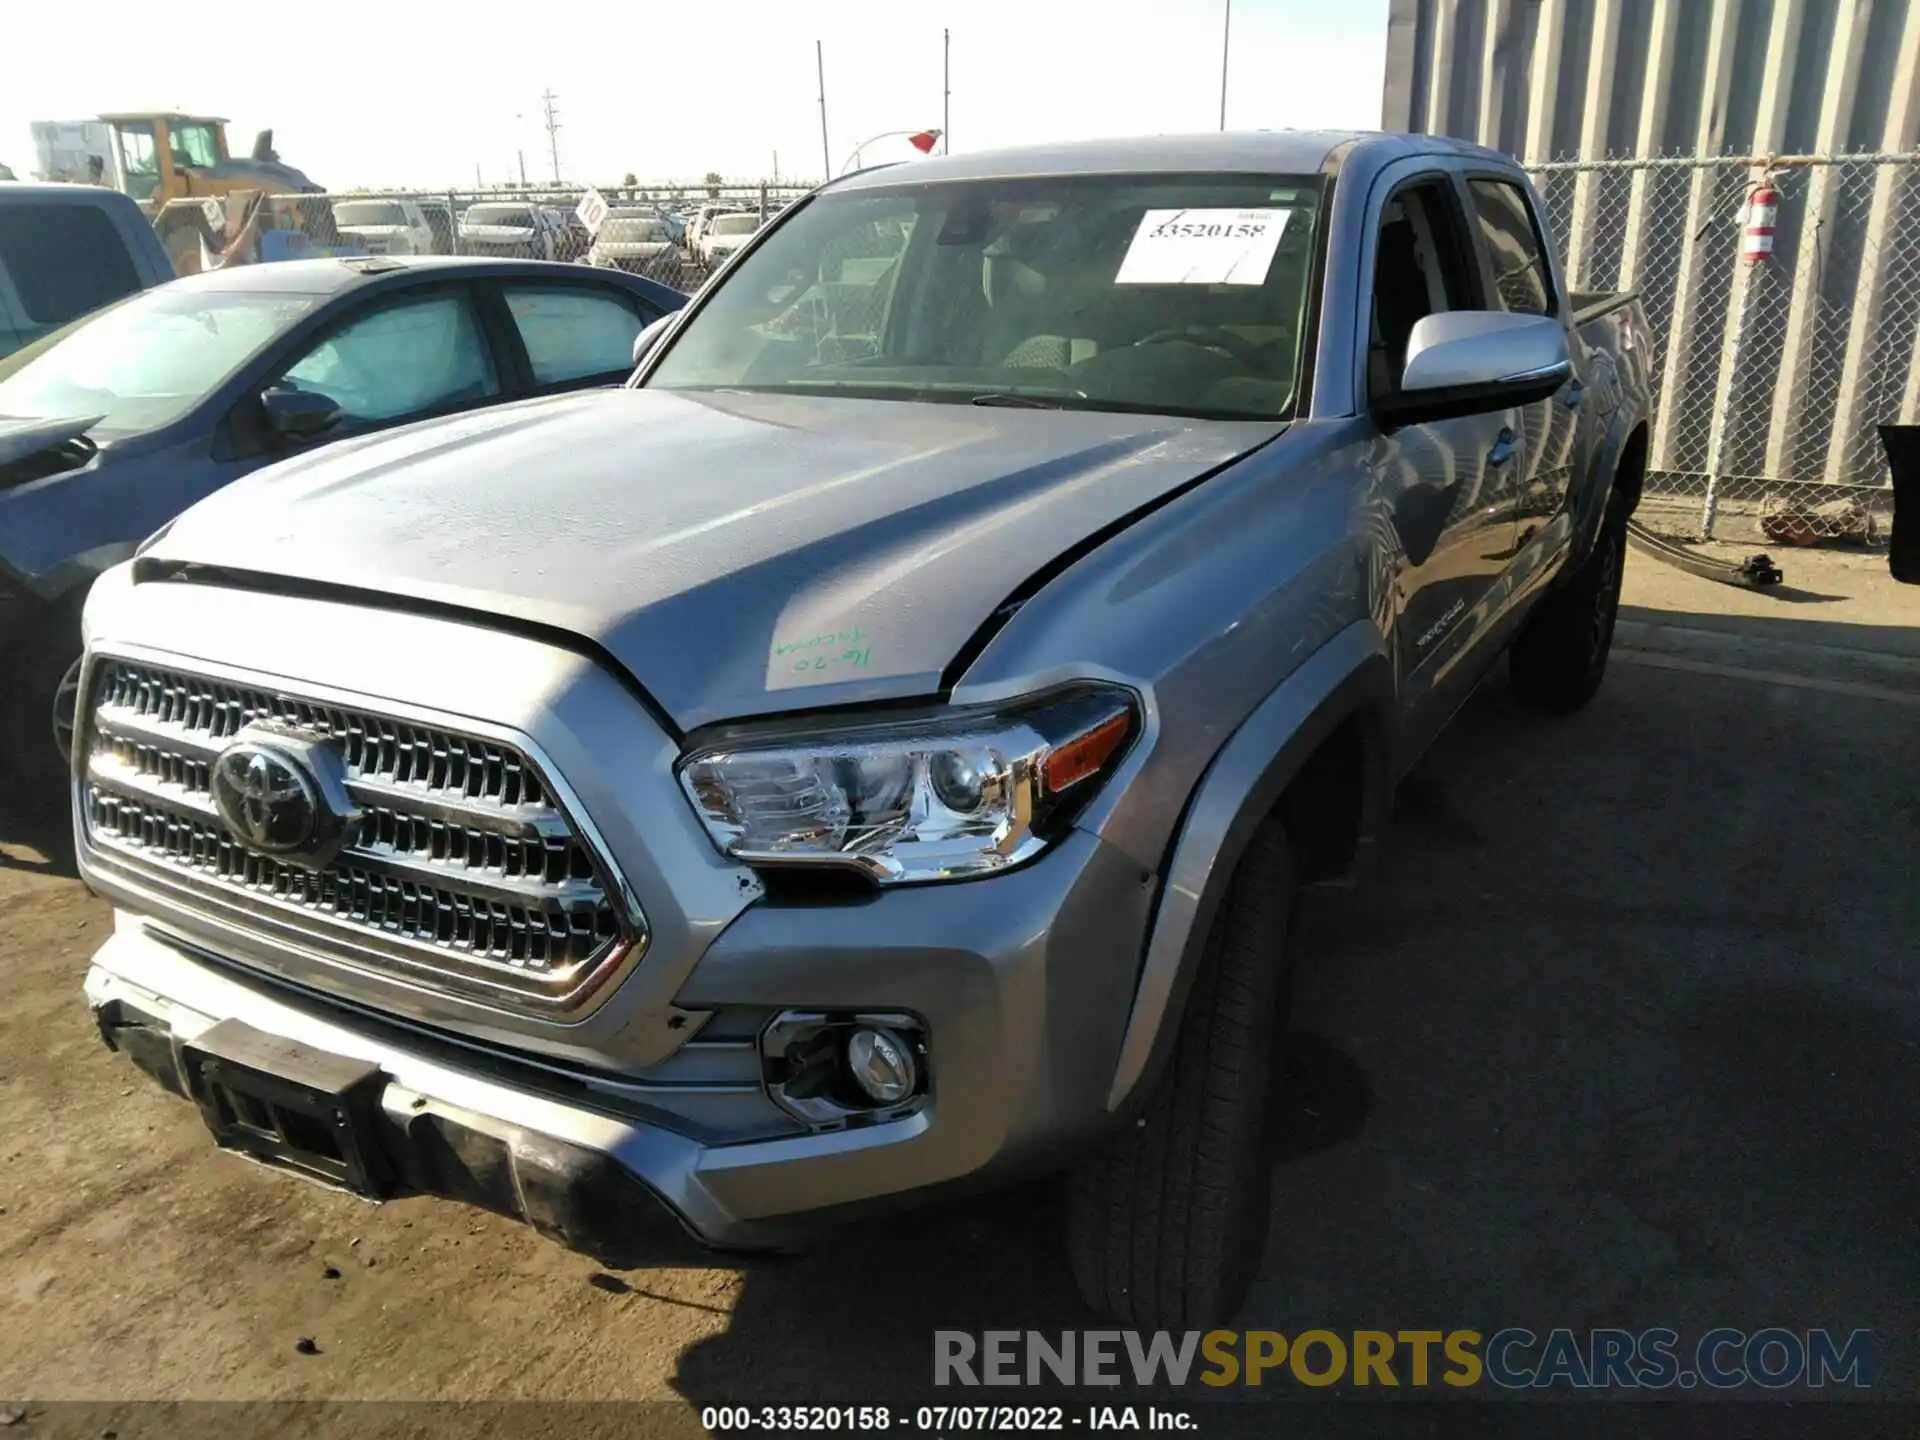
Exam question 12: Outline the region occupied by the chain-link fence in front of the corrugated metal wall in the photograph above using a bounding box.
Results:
[1532,154,1920,543]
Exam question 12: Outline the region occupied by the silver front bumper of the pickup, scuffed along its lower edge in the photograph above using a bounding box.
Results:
[86,833,1154,1260]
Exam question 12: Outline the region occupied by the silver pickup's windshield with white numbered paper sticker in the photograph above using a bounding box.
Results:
[647,175,1321,419]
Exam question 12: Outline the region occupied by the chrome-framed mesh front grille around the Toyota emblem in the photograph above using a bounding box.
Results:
[81,657,643,1010]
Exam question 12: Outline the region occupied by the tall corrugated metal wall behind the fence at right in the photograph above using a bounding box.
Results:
[1382,0,1920,526]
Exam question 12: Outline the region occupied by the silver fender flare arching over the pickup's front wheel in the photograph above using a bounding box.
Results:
[1108,620,1396,1114]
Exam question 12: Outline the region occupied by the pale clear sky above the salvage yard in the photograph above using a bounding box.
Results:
[0,0,1386,188]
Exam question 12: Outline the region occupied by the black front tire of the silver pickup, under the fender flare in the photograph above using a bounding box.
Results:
[1068,820,1294,1331]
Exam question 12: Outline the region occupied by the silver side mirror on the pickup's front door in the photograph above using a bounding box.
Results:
[1373,309,1572,426]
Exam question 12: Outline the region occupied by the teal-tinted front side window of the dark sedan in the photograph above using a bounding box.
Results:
[280,296,499,422]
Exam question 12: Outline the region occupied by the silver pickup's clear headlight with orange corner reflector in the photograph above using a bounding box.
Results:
[680,685,1139,885]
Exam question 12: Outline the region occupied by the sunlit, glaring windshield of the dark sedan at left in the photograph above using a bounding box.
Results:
[0,286,319,436]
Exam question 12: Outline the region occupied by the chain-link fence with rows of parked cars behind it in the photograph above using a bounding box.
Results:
[240,180,810,290]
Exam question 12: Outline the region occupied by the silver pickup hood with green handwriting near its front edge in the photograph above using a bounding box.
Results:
[150,390,1283,730]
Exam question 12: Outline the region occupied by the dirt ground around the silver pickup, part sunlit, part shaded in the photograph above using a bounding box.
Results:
[0,555,1920,1432]
